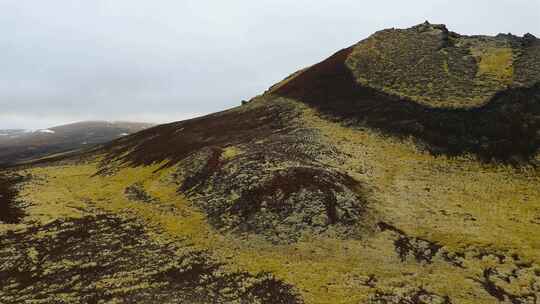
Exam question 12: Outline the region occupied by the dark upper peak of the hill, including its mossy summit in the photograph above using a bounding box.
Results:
[268,24,540,164]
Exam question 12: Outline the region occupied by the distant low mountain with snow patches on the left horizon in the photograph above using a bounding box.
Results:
[0,121,152,164]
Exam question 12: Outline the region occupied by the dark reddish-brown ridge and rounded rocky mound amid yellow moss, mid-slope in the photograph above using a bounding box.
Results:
[101,97,368,243]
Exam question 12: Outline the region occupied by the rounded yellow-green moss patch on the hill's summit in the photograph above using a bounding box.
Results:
[346,26,524,108]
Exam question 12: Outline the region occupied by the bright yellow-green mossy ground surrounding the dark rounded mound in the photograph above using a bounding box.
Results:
[0,98,540,304]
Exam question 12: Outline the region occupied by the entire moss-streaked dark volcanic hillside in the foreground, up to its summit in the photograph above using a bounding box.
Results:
[0,24,540,304]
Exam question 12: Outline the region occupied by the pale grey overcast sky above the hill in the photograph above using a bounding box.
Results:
[0,0,540,129]
